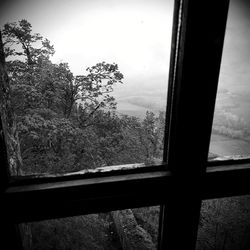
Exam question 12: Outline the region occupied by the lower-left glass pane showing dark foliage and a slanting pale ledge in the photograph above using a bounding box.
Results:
[20,206,159,250]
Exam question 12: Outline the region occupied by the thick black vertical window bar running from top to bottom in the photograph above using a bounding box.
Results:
[160,0,229,250]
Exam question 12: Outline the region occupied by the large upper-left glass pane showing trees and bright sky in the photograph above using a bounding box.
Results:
[0,0,174,175]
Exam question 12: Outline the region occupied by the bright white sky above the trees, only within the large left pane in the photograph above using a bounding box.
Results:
[0,0,173,104]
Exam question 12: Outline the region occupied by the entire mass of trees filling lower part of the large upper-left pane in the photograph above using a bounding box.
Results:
[1,20,164,174]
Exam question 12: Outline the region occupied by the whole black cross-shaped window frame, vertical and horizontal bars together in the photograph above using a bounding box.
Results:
[0,0,250,249]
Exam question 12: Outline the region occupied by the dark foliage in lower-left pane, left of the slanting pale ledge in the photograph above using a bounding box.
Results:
[29,214,120,250]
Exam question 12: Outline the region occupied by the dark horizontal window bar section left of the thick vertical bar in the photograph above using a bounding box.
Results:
[1,171,171,222]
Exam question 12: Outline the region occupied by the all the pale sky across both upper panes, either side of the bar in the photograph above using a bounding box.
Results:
[0,0,250,111]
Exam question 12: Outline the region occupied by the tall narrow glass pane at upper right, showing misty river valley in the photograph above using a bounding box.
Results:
[210,0,250,159]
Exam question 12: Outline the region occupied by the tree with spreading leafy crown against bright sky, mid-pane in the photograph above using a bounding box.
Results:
[53,62,123,120]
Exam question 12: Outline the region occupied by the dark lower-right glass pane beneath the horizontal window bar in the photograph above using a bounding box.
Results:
[196,196,250,250]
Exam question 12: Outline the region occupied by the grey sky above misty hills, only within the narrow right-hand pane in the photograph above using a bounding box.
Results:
[219,0,250,94]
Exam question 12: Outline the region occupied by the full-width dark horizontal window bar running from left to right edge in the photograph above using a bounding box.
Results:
[1,164,250,222]
